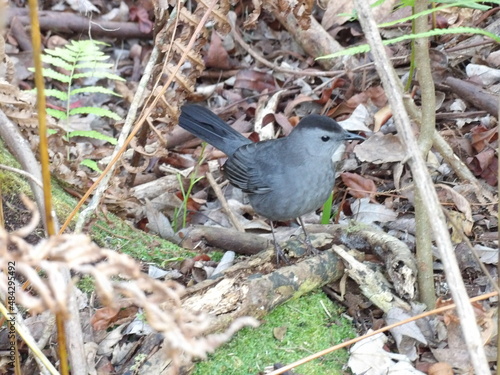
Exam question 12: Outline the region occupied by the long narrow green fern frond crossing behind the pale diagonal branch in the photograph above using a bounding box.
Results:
[316,27,500,60]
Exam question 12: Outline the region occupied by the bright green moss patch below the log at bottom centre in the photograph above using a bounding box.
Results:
[194,292,355,375]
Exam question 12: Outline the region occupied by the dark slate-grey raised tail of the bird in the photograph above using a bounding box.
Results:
[179,104,251,156]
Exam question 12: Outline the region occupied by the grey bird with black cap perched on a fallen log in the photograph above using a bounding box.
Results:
[179,104,364,262]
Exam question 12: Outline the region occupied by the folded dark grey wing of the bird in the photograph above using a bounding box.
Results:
[224,143,271,194]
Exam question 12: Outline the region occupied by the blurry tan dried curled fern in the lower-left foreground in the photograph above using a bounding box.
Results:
[0,198,257,372]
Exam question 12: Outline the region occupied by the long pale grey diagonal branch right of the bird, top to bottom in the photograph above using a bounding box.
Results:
[355,0,490,374]
